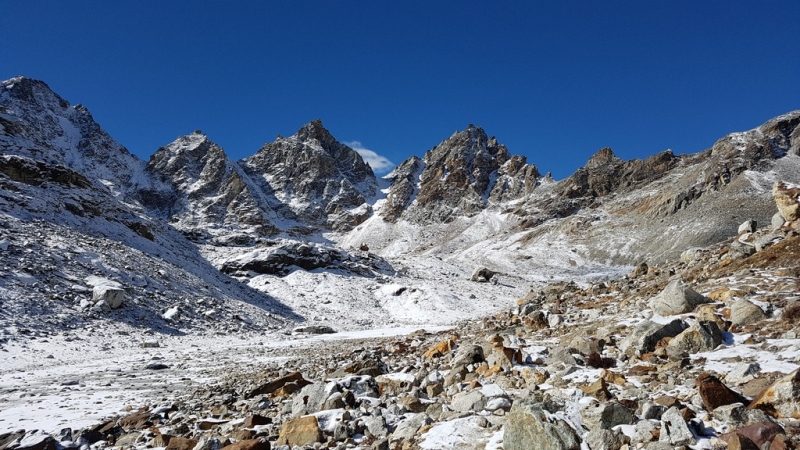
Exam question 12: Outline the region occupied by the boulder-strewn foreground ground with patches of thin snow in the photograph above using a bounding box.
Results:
[0,192,800,450]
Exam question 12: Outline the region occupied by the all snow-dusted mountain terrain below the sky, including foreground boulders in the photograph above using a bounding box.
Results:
[0,77,800,450]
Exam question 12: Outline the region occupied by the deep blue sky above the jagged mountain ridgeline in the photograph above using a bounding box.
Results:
[0,0,800,178]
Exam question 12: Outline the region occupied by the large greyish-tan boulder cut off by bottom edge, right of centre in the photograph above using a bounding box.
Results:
[503,402,581,450]
